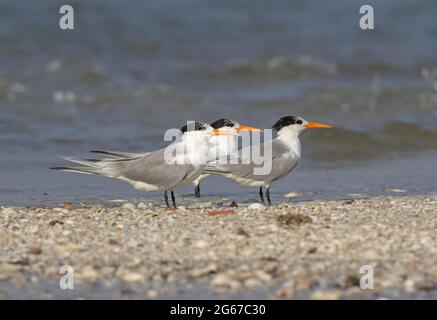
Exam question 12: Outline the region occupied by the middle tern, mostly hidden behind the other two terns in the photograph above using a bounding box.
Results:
[193,118,261,198]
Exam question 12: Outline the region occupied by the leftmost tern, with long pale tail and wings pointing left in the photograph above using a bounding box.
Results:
[51,122,236,208]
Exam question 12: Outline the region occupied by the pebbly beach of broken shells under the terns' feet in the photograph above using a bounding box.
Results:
[0,195,437,299]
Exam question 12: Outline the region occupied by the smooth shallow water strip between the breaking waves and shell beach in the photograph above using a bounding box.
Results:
[1,148,437,206]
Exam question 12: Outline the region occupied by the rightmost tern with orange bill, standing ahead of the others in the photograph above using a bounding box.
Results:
[204,116,332,205]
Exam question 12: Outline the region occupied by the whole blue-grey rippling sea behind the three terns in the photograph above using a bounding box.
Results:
[0,0,437,205]
